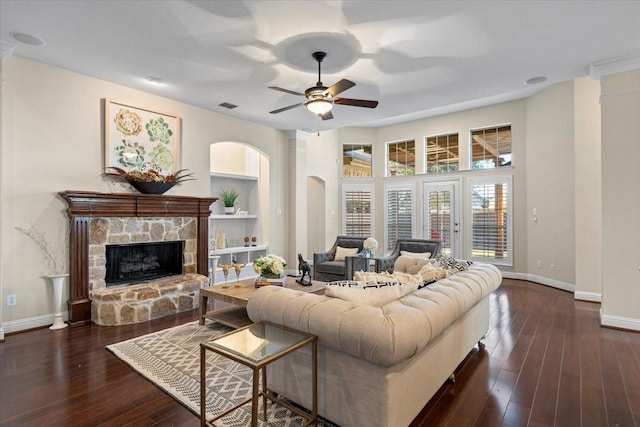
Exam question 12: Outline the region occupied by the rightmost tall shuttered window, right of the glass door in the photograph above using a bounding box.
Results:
[470,177,513,265]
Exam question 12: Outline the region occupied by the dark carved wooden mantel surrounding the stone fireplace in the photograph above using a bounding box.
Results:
[58,190,218,324]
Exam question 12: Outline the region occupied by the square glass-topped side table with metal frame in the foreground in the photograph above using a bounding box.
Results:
[200,322,318,427]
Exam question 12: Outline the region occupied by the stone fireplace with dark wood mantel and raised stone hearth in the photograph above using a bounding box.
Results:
[59,191,217,325]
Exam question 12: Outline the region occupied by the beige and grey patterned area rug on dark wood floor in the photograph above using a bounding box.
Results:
[107,322,334,427]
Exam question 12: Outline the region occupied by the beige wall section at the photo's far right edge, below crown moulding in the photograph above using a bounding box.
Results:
[601,70,640,330]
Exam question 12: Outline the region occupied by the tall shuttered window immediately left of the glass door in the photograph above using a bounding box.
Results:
[385,185,414,250]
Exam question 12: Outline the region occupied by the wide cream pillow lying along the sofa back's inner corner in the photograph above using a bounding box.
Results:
[324,280,418,307]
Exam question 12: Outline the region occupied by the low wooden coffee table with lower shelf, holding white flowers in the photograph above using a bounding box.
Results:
[200,277,326,328]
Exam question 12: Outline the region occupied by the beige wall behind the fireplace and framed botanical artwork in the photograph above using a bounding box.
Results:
[0,56,289,332]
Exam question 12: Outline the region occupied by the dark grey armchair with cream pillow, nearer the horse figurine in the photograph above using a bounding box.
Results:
[313,236,366,282]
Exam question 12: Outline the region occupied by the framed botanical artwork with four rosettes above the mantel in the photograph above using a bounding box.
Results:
[104,99,180,174]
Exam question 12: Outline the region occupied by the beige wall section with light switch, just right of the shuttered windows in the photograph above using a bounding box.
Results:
[522,81,575,290]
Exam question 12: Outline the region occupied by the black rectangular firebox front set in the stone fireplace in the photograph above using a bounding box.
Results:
[105,240,184,286]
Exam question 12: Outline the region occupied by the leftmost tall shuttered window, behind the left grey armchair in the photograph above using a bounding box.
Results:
[342,185,374,237]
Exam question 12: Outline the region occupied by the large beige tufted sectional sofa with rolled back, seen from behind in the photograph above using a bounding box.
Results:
[247,263,502,427]
